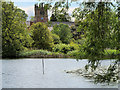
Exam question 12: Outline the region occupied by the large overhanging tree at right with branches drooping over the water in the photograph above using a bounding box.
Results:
[73,2,120,83]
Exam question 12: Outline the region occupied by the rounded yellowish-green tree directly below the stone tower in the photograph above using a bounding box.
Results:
[30,22,53,50]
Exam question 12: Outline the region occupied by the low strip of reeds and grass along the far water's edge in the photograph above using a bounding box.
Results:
[18,49,120,59]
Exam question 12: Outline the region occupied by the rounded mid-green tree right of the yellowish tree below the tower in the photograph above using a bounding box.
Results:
[52,23,72,44]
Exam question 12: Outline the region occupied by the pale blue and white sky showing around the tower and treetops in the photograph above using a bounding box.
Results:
[8,0,79,21]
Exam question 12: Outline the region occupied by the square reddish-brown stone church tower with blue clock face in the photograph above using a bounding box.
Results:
[35,3,48,23]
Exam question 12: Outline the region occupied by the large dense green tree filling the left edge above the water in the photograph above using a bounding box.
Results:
[2,2,33,57]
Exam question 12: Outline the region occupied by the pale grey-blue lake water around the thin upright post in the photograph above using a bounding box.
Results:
[2,59,118,88]
